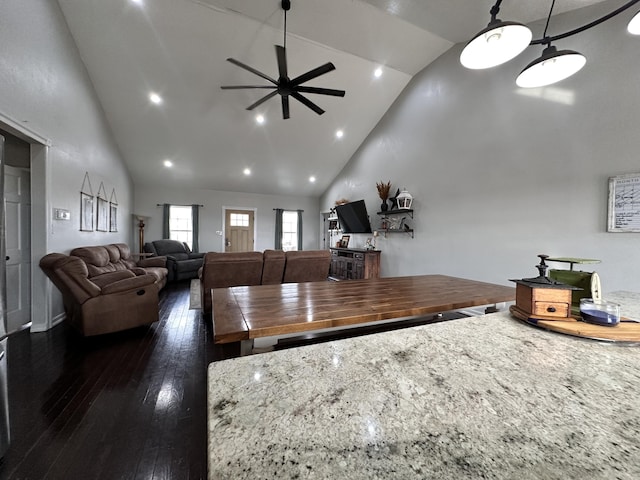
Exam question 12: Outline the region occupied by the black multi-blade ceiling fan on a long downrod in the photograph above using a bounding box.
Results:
[220,0,345,120]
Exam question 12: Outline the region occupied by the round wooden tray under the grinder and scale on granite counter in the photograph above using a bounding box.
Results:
[509,305,640,343]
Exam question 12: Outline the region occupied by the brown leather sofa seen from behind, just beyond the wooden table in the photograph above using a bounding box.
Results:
[199,250,331,313]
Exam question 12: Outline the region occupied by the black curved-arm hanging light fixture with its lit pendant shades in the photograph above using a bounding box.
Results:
[460,0,640,88]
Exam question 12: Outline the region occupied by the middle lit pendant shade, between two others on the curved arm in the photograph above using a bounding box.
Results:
[516,45,587,88]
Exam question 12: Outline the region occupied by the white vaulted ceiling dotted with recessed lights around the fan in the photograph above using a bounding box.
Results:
[58,0,600,196]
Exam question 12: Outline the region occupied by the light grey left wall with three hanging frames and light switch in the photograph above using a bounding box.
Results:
[0,0,133,331]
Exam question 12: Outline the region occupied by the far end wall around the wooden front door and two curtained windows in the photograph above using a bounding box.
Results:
[131,185,320,252]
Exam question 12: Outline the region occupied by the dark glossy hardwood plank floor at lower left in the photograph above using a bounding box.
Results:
[0,282,226,480]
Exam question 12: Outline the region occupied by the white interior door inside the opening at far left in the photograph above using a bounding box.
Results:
[4,165,31,332]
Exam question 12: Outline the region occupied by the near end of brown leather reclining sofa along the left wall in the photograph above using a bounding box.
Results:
[40,253,158,336]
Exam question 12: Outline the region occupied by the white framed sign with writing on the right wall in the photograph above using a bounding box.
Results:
[607,173,640,233]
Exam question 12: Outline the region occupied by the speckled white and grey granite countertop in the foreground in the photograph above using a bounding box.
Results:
[209,292,640,480]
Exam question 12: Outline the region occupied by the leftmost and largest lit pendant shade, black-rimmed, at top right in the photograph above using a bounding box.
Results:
[460,20,533,70]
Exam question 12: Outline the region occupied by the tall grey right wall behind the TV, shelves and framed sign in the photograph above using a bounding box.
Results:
[321,2,640,292]
